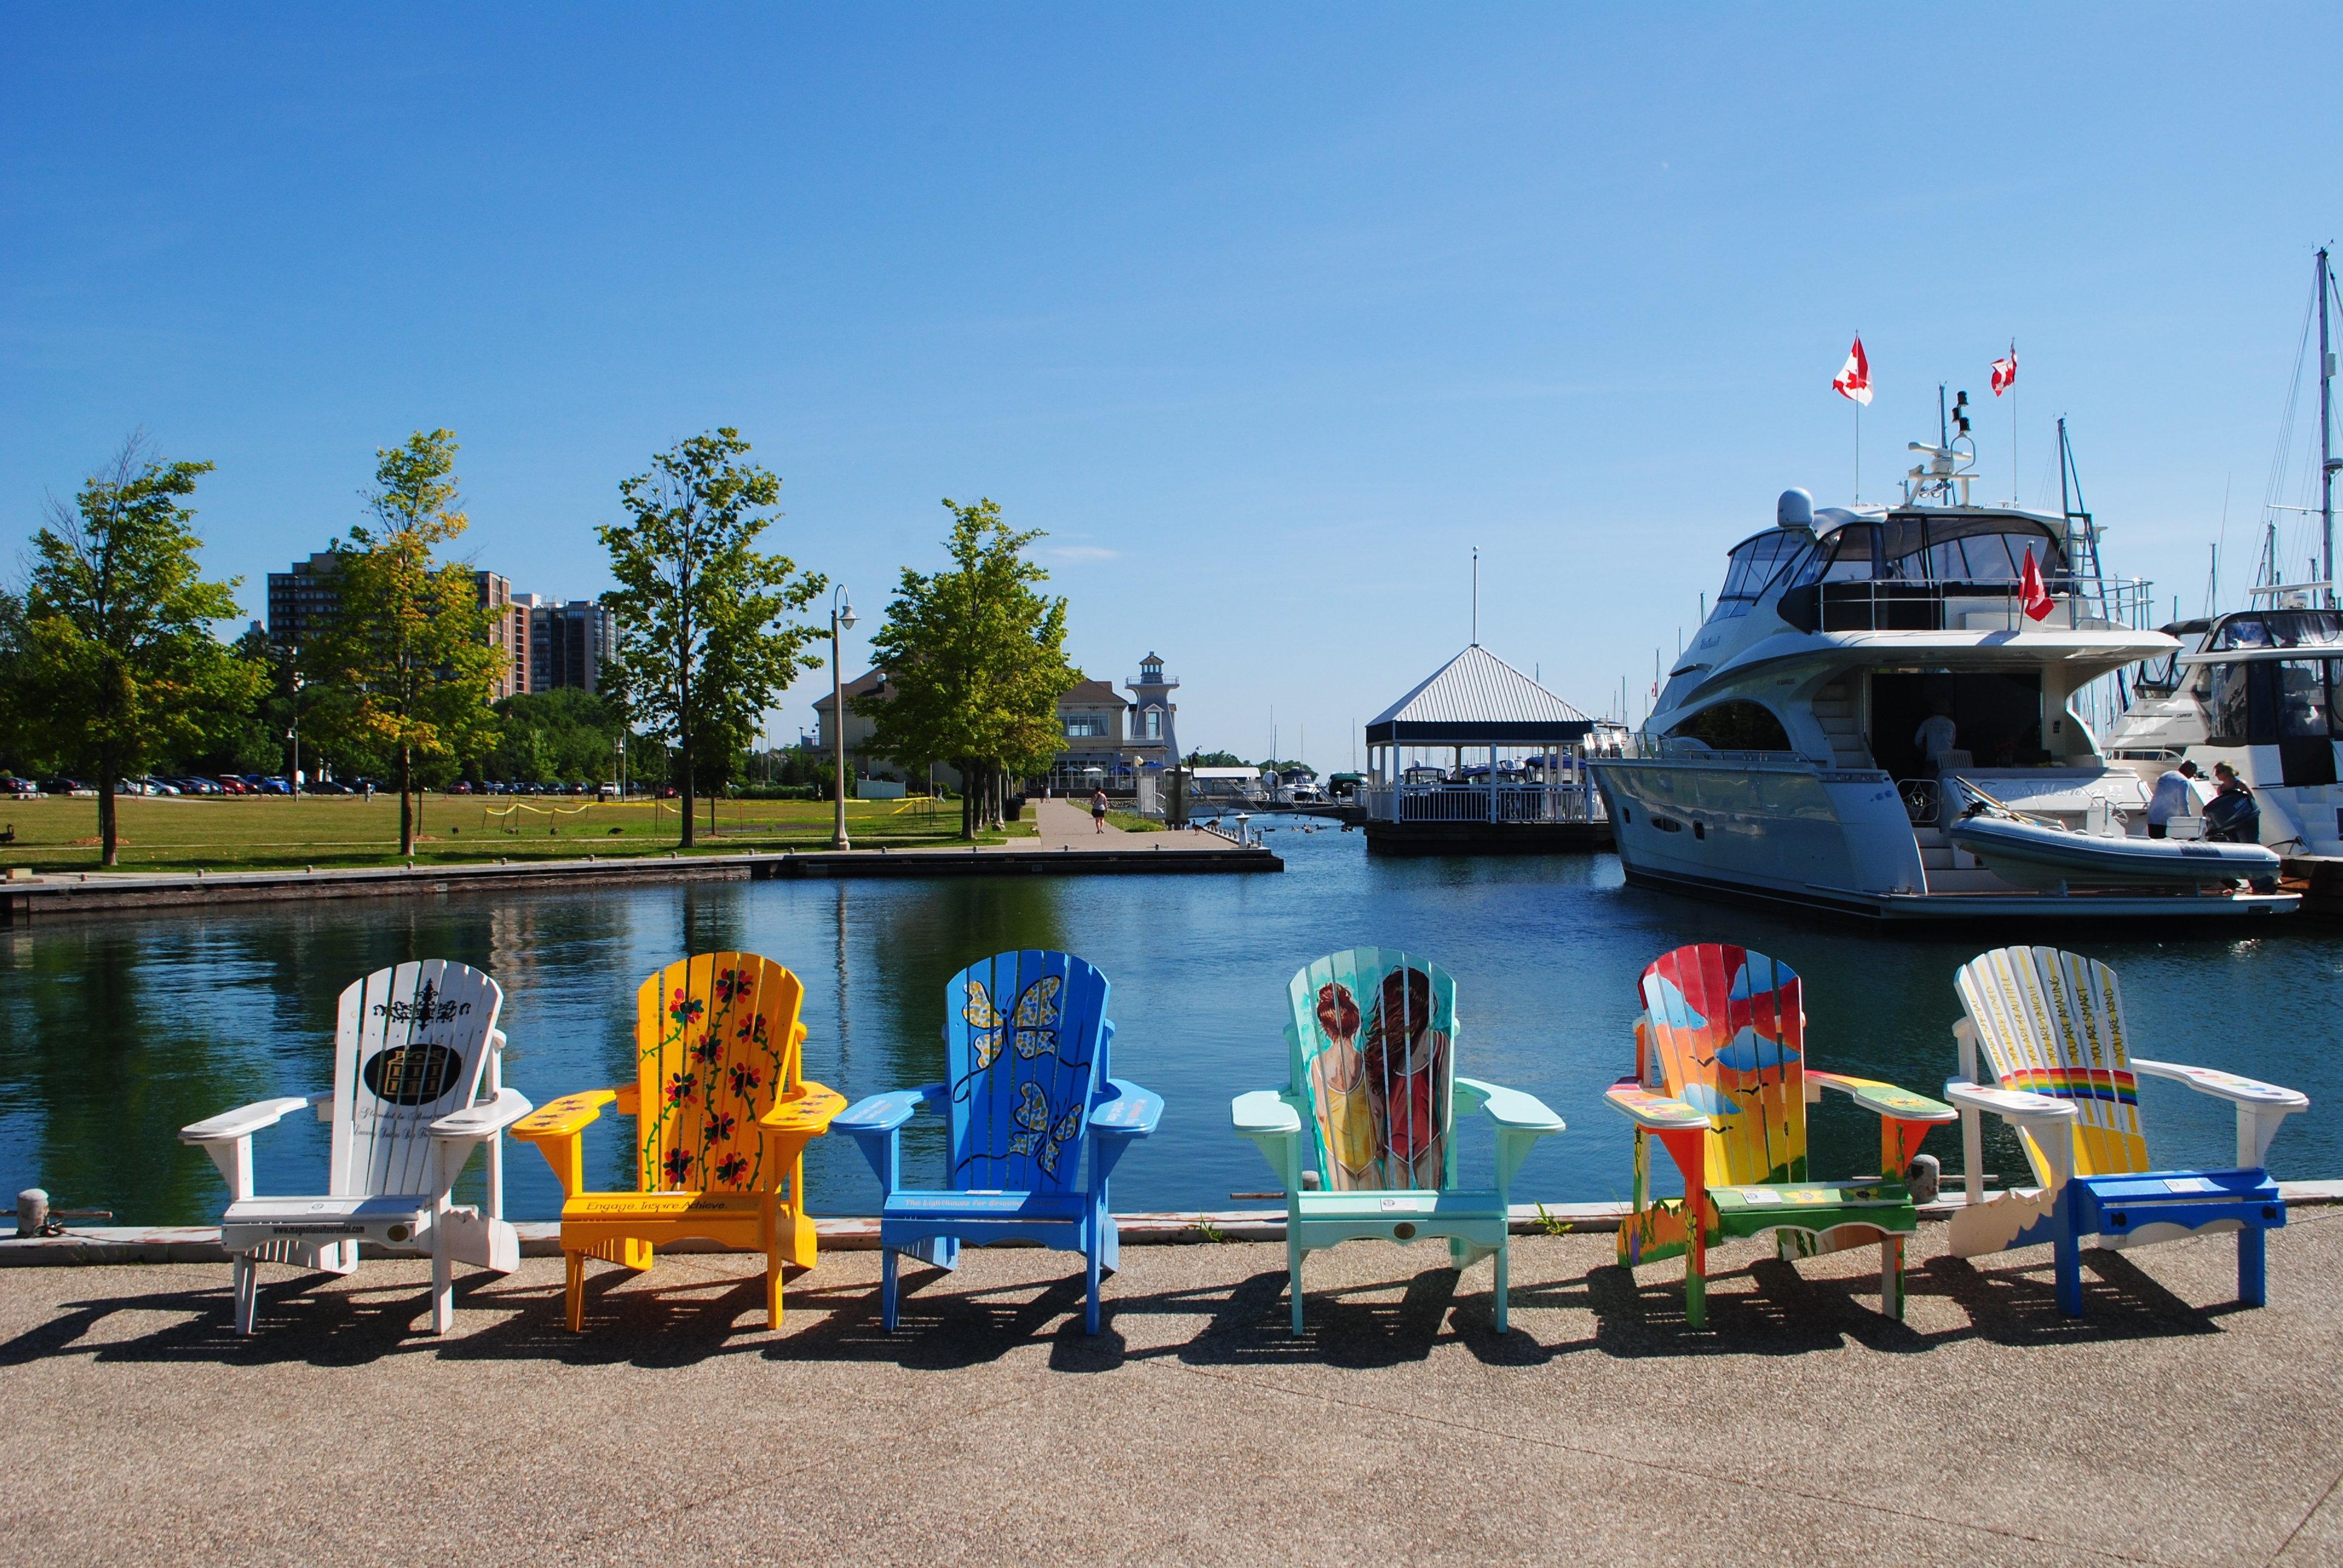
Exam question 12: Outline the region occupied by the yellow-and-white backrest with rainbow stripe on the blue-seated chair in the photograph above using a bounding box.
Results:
[1954,947,2151,1181]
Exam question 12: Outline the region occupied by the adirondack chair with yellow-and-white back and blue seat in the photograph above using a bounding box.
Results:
[1945,947,2310,1317]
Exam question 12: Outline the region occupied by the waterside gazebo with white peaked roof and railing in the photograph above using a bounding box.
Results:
[1362,642,1610,853]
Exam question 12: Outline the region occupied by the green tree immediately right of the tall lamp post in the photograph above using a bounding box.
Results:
[855,497,1083,839]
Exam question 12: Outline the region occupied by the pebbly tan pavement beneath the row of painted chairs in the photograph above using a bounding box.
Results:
[0,1209,2343,1568]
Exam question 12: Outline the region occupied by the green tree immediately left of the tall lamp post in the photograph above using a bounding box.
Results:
[600,426,830,849]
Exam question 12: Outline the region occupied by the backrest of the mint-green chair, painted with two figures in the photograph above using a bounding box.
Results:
[1286,947,1462,1191]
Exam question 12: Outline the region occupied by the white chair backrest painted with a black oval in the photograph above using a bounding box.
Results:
[328,959,503,1198]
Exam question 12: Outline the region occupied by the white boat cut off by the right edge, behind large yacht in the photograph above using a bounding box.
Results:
[2106,584,2343,900]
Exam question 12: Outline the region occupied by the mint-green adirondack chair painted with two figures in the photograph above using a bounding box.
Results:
[1230,947,1563,1334]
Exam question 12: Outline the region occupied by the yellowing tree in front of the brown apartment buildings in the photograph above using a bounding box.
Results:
[302,429,506,855]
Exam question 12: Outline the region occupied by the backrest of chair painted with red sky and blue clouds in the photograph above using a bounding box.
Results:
[1638,942,1806,1186]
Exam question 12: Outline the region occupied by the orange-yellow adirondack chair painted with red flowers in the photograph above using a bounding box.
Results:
[513,954,846,1331]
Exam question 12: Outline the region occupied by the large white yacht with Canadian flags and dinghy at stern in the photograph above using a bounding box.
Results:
[1588,443,2301,921]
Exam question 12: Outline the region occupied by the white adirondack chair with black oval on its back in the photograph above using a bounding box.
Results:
[178,959,529,1334]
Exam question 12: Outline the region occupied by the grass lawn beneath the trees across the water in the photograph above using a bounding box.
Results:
[0,794,1034,872]
